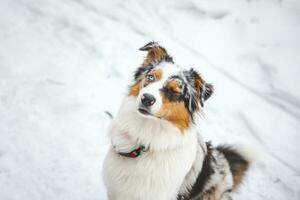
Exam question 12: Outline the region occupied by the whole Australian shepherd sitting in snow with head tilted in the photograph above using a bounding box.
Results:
[103,42,251,200]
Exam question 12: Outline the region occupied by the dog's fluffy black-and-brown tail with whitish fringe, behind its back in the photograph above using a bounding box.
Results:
[216,145,254,189]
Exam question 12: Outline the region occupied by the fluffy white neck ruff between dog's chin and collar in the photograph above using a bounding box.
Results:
[110,97,197,152]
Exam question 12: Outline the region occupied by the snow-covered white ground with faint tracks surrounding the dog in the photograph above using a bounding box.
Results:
[0,0,300,200]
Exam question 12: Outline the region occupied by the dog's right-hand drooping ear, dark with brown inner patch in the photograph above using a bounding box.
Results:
[189,68,214,107]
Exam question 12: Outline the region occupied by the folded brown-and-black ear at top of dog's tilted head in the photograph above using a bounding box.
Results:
[139,42,173,67]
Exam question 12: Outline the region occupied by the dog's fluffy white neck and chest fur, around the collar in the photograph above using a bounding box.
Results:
[103,97,197,200]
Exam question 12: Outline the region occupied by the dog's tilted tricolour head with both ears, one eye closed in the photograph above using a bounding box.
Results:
[129,42,213,132]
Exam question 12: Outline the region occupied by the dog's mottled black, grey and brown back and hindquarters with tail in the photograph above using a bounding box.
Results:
[177,143,253,200]
